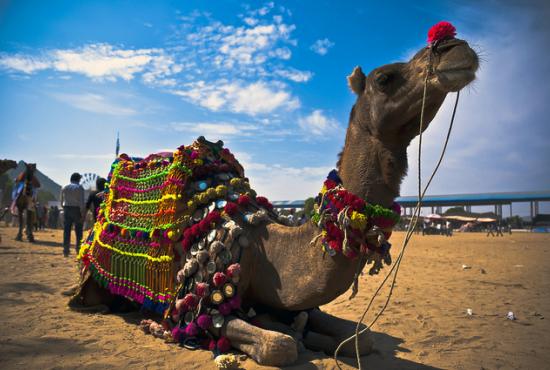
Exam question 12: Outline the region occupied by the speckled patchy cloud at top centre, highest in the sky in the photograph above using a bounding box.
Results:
[174,4,296,80]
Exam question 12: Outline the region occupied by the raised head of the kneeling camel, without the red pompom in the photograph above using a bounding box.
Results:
[348,38,479,147]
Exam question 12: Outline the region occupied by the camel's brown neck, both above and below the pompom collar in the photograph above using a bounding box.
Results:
[254,121,407,310]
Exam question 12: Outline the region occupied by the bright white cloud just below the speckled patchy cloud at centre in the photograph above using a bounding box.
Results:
[173,81,300,115]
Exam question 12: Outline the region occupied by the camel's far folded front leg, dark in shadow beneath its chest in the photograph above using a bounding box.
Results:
[304,309,373,357]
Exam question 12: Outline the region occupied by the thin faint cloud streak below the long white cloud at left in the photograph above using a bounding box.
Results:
[51,93,137,116]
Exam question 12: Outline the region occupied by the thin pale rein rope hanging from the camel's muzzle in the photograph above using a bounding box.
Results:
[334,49,460,370]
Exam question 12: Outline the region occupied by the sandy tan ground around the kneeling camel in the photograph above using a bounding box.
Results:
[0,228,550,369]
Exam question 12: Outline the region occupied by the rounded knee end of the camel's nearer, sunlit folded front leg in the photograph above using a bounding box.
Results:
[252,332,298,366]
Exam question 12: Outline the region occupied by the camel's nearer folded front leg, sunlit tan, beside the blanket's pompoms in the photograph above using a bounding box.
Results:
[222,318,298,366]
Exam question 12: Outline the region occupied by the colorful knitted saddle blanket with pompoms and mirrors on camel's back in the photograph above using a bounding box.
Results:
[79,137,276,348]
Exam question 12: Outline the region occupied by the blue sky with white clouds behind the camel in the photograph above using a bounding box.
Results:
[0,1,550,212]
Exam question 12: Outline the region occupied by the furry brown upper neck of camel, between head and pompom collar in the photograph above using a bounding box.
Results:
[338,123,407,207]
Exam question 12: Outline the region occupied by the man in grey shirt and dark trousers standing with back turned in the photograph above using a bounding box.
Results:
[60,172,86,257]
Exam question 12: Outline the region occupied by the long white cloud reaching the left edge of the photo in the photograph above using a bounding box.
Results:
[0,43,181,84]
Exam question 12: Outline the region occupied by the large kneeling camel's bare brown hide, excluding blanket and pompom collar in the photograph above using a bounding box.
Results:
[72,34,478,366]
